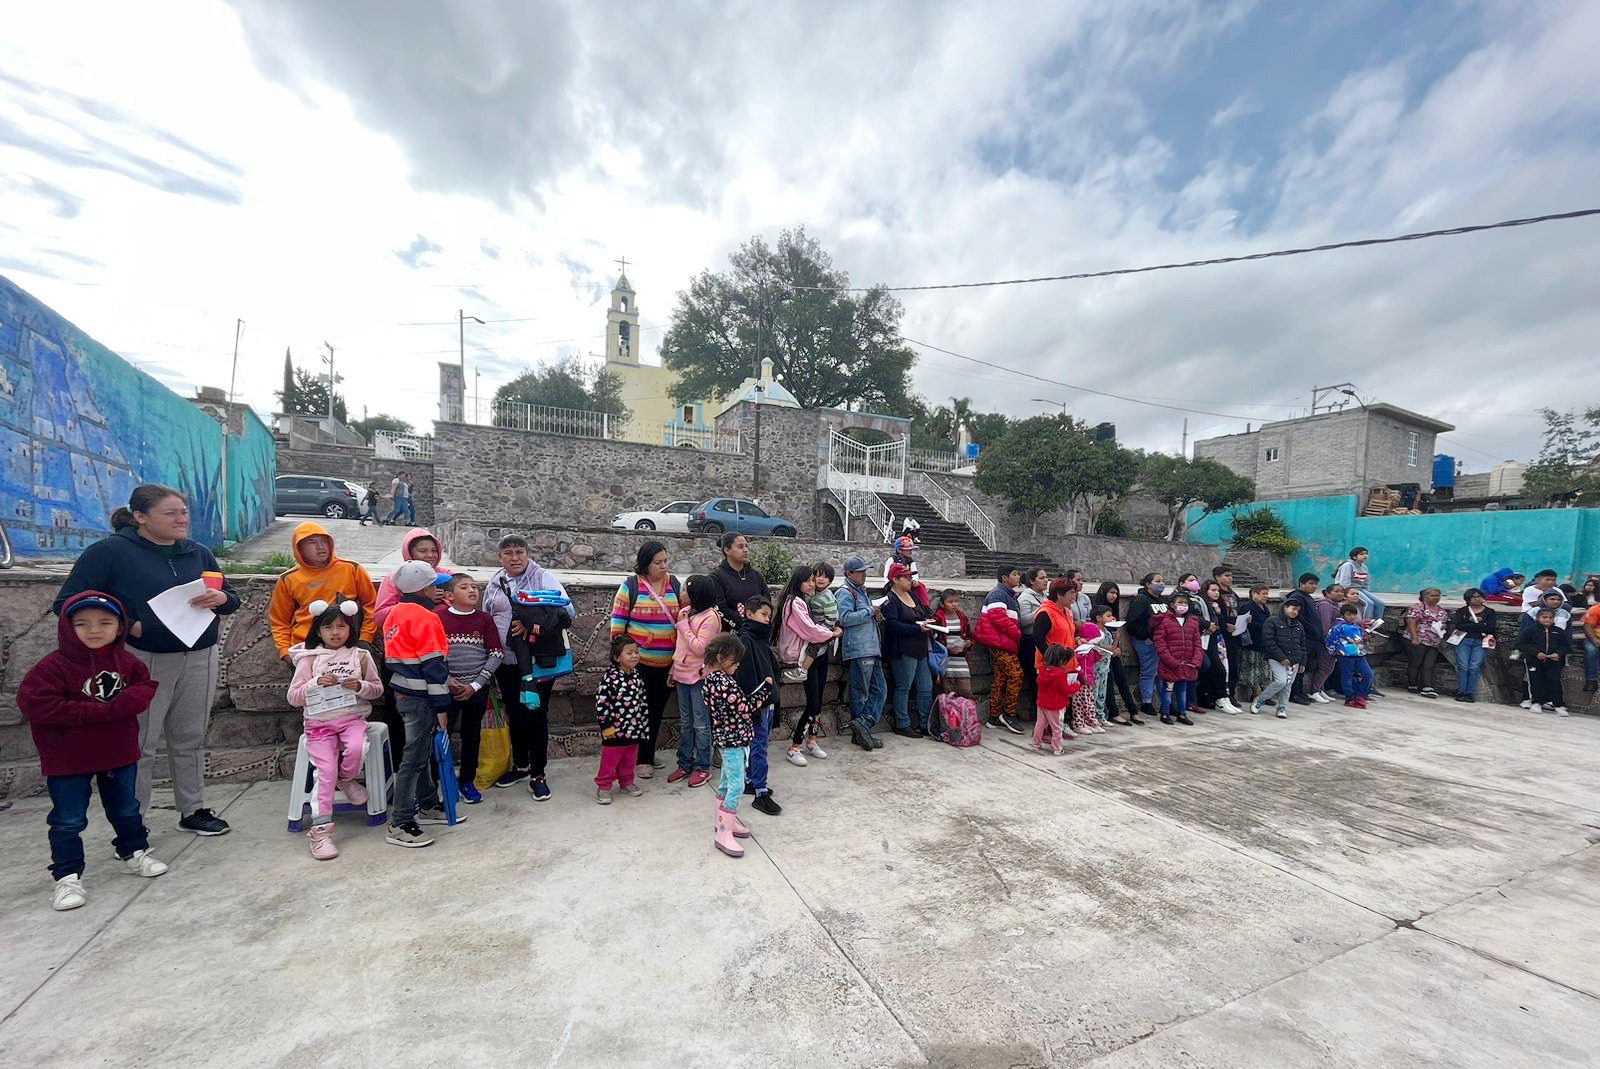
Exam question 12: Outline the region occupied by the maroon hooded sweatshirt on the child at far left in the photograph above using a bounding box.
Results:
[16,591,155,776]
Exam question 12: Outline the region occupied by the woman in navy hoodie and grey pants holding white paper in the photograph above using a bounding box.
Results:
[53,483,238,835]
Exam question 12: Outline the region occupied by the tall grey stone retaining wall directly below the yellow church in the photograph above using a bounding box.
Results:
[434,410,816,535]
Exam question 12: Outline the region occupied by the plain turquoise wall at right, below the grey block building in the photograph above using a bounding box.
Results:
[1187,494,1600,594]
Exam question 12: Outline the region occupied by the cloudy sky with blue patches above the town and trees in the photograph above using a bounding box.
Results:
[0,0,1600,470]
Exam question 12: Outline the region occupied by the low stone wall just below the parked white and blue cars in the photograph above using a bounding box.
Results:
[440,517,966,579]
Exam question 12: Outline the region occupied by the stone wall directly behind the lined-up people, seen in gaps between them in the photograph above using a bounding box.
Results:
[0,570,1586,799]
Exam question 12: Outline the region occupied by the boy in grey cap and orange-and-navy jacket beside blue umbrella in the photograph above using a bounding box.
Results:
[384,560,467,848]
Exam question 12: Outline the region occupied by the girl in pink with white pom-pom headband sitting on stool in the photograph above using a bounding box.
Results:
[288,594,384,861]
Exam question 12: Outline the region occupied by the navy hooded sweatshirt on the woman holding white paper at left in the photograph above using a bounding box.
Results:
[51,526,238,653]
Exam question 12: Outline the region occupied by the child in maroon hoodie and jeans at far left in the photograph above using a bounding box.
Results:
[16,591,166,909]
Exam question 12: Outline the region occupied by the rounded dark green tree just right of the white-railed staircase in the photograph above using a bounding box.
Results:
[978,414,1139,533]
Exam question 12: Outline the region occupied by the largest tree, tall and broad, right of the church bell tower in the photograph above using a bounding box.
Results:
[661,229,915,411]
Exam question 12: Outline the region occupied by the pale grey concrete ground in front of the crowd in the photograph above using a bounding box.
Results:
[0,698,1600,1069]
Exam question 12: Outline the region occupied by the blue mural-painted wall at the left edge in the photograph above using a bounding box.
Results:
[0,277,277,557]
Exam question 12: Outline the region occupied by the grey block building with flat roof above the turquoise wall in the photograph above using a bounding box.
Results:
[1194,405,1456,501]
